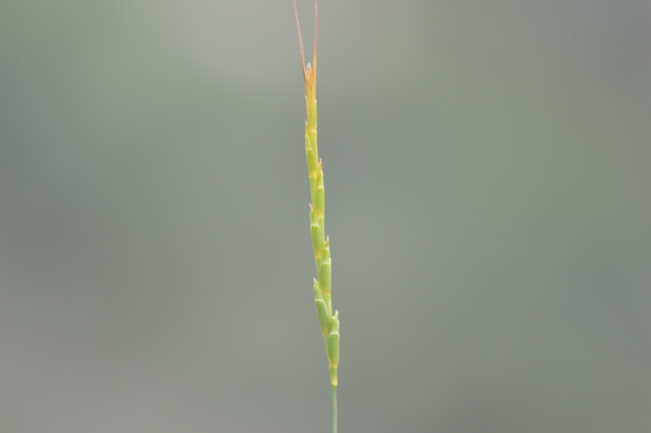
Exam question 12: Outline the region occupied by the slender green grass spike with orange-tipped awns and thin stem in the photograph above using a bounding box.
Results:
[294,0,339,433]
